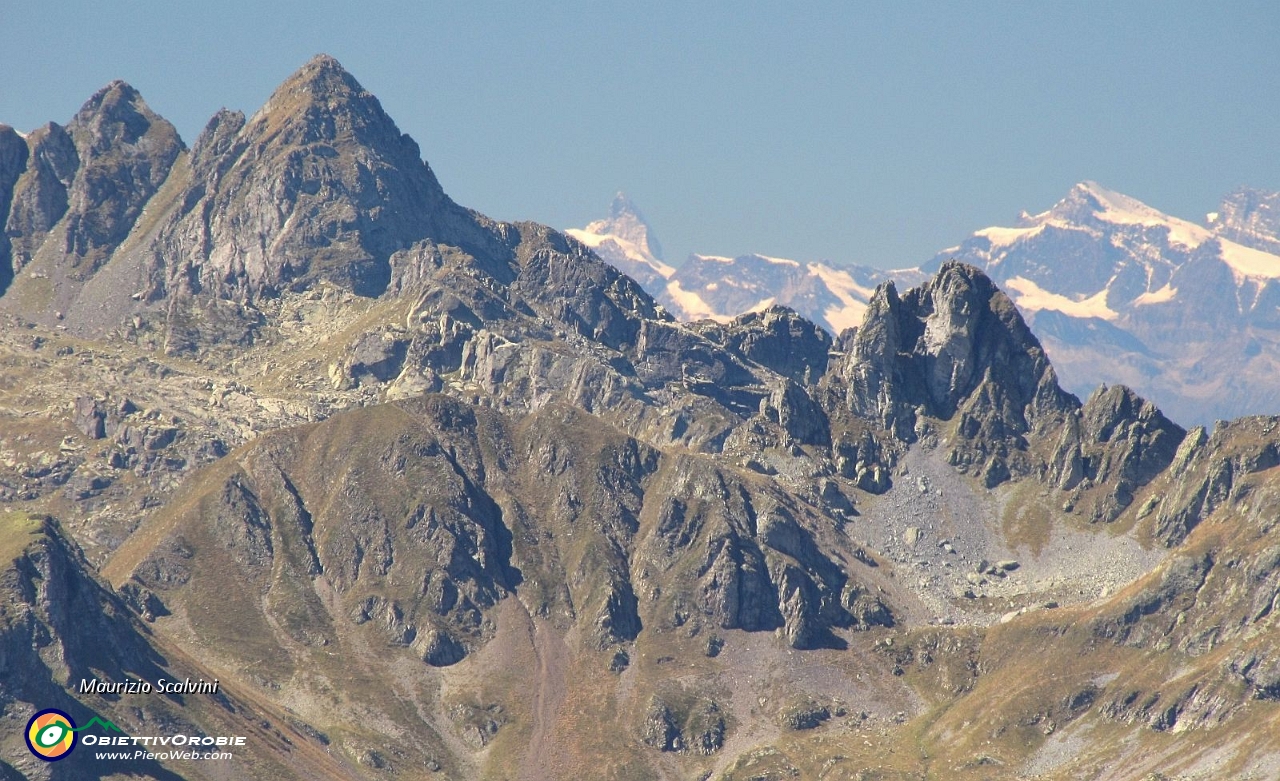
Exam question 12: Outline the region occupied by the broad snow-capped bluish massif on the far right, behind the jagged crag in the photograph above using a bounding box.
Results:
[925,182,1280,424]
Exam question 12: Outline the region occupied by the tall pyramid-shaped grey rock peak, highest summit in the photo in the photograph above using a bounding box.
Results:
[155,56,460,301]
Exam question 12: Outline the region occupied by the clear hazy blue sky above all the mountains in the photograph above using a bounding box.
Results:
[0,0,1280,266]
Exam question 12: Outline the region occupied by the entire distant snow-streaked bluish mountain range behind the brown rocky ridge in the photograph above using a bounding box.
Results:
[568,182,1280,424]
